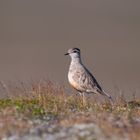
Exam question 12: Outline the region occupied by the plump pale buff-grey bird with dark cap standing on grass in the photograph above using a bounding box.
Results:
[65,48,113,103]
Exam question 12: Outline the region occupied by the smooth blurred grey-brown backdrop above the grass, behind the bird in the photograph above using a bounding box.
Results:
[0,0,140,97]
